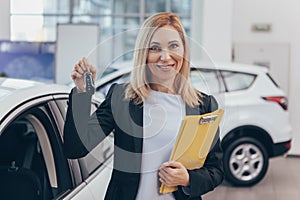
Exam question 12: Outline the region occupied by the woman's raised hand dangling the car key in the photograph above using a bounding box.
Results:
[71,57,97,92]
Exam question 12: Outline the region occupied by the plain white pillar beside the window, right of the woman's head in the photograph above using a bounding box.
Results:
[191,0,232,62]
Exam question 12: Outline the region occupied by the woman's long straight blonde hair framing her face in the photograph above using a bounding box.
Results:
[125,12,202,107]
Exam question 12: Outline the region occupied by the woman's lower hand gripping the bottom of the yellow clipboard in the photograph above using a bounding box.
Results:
[158,162,190,187]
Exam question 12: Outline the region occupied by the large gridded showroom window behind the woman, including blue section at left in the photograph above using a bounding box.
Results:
[5,0,192,83]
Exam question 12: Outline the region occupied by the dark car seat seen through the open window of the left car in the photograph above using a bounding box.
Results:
[0,123,43,200]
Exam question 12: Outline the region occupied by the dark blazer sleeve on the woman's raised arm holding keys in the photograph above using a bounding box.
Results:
[63,85,115,159]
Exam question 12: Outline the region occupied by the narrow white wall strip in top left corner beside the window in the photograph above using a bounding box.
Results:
[0,0,10,40]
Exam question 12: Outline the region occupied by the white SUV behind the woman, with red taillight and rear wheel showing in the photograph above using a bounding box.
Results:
[95,62,292,186]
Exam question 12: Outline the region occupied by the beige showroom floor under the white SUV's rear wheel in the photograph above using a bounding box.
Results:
[203,156,300,200]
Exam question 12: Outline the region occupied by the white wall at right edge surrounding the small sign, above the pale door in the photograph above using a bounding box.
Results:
[232,0,300,154]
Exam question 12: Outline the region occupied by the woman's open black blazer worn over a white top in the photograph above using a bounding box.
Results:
[64,84,224,200]
